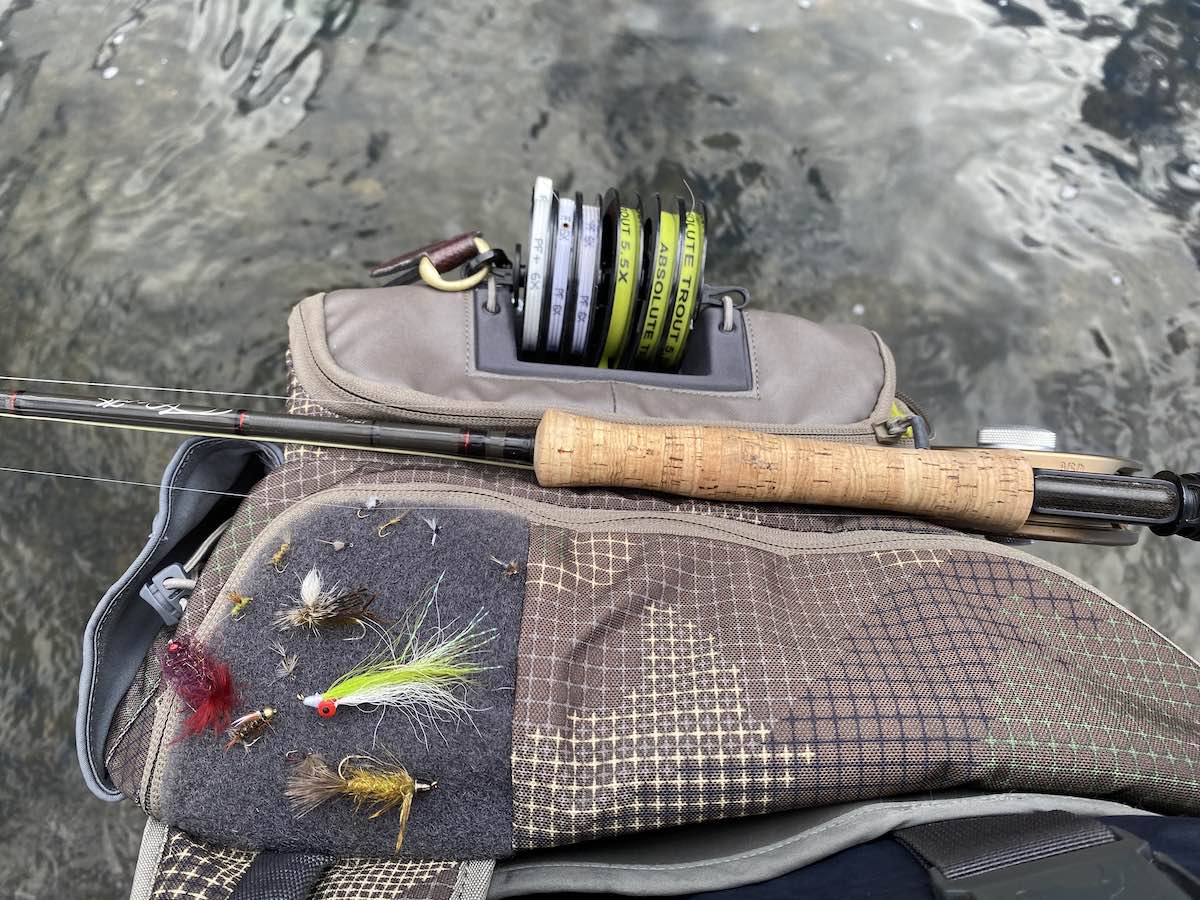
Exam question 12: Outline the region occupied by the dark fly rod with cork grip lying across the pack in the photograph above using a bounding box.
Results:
[0,391,1200,540]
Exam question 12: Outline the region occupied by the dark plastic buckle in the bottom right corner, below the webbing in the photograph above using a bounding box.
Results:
[929,826,1200,900]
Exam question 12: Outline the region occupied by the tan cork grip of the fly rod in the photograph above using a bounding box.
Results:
[534,409,1033,534]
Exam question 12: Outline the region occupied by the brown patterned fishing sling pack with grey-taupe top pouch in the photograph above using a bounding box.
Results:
[78,282,1200,899]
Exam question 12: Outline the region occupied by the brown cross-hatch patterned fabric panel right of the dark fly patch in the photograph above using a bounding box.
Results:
[512,528,1200,847]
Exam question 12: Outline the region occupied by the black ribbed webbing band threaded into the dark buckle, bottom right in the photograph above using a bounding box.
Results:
[894,811,1116,878]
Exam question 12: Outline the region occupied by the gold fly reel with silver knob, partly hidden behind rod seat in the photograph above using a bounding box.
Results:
[947,426,1141,547]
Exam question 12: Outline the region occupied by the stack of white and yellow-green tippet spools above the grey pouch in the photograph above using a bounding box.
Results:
[512,178,708,372]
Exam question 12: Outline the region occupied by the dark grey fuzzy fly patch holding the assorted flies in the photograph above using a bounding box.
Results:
[162,508,529,859]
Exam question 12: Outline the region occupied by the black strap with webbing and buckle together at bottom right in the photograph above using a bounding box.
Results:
[893,811,1200,900]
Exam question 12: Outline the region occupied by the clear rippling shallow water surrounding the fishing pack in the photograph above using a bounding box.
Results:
[0,0,1200,898]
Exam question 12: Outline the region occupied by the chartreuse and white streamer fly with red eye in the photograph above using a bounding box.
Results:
[304,572,496,727]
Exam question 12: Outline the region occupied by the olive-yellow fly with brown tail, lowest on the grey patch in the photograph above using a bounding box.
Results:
[283,754,438,853]
